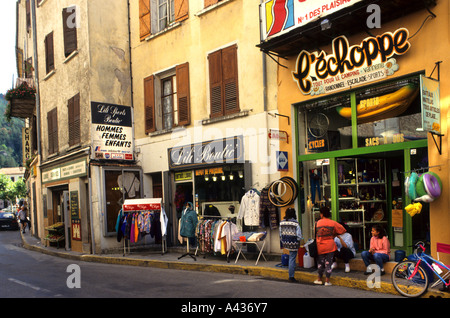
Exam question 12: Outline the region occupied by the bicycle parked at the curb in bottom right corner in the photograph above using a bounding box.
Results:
[391,242,450,297]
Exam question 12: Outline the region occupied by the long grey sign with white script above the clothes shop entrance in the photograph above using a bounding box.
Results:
[168,136,244,169]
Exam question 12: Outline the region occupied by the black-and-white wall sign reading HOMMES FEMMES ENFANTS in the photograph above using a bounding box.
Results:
[91,102,134,160]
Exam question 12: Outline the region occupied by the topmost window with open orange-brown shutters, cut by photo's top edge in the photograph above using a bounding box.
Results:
[139,0,189,41]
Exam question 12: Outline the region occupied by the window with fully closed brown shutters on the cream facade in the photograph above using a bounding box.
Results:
[208,45,240,118]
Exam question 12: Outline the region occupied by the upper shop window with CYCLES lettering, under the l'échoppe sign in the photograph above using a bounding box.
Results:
[299,95,352,155]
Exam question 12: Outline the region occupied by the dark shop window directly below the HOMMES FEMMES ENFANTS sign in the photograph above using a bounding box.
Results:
[104,170,141,234]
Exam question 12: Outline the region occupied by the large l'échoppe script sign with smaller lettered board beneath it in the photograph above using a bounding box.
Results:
[292,28,411,95]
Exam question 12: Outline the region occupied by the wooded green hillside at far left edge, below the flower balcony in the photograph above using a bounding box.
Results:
[0,94,24,168]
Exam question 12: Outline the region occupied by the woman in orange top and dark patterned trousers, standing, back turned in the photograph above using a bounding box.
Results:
[314,206,346,286]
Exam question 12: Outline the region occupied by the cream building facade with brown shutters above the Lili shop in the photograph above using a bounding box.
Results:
[130,0,280,251]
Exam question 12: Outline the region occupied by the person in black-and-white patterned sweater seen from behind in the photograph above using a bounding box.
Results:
[280,208,302,282]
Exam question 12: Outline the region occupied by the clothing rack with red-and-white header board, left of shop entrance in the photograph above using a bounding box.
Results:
[122,198,167,256]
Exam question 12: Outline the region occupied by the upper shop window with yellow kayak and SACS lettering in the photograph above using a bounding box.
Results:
[356,77,427,147]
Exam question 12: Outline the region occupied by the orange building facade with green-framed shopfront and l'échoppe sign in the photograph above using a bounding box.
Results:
[258,0,450,262]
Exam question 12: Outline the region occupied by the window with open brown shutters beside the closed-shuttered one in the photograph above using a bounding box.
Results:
[144,63,190,133]
